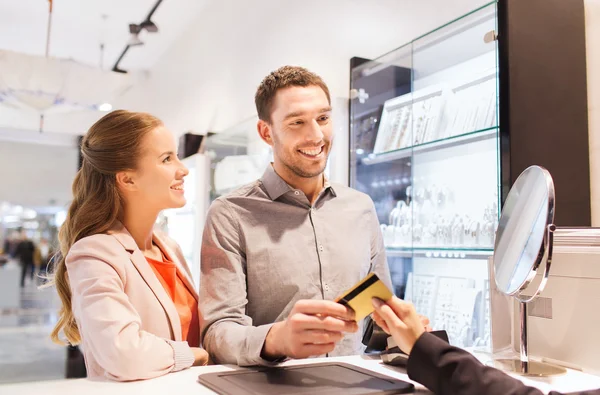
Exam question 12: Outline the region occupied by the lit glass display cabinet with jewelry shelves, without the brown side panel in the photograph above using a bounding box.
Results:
[350,2,500,347]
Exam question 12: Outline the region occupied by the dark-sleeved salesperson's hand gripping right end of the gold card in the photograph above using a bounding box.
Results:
[373,296,425,354]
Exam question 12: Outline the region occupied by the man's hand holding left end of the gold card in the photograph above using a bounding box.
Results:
[263,300,358,359]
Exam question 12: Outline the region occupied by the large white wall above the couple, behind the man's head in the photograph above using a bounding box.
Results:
[117,0,485,182]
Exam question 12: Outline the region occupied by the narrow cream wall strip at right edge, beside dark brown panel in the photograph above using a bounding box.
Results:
[585,0,600,226]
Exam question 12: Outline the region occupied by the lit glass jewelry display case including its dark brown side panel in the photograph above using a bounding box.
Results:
[349,0,591,349]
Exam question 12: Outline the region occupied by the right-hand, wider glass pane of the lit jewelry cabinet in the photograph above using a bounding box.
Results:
[405,3,499,347]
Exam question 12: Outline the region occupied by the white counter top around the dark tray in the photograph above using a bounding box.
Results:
[0,354,600,395]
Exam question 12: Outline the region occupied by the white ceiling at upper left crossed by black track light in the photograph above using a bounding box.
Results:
[0,0,208,70]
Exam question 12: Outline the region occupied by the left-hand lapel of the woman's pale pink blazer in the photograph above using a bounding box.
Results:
[109,225,182,341]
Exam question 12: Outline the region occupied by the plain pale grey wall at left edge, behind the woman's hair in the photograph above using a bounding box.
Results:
[0,141,77,207]
